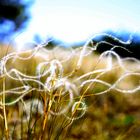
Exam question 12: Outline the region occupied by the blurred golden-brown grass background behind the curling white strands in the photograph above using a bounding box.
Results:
[0,43,140,140]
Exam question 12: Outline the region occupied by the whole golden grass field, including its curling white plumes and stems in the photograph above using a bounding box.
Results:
[0,46,140,140]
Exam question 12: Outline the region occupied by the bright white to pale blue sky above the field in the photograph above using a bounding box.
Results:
[13,0,140,47]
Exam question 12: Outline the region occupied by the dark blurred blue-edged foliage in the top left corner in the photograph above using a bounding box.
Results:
[0,0,33,41]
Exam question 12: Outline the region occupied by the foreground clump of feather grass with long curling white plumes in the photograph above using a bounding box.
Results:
[0,34,140,139]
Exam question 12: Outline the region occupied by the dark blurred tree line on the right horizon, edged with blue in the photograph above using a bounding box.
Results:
[92,33,140,59]
